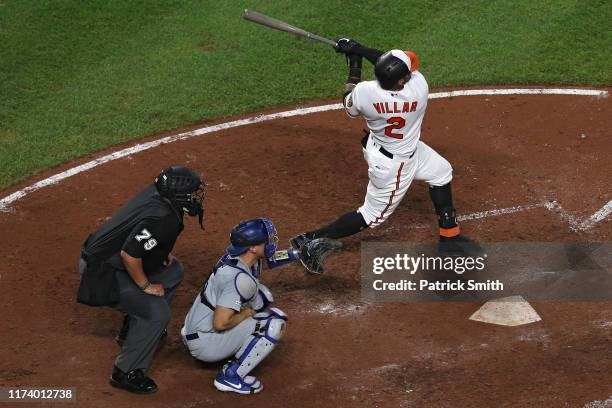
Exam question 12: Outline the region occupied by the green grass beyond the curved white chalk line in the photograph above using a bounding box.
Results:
[0,0,612,189]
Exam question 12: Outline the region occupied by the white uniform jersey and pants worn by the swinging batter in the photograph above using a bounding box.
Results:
[344,50,453,228]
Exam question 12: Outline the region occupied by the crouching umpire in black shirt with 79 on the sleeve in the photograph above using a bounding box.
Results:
[77,167,206,394]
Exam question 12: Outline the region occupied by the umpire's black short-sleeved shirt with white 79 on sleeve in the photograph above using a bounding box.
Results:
[78,185,183,305]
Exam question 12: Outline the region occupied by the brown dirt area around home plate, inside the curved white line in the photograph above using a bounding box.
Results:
[0,89,612,408]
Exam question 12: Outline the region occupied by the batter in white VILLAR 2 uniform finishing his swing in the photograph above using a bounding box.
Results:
[291,39,481,256]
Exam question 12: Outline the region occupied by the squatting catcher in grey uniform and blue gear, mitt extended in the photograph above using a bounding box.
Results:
[181,218,341,394]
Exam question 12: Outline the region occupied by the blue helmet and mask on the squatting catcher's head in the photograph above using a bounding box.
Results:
[227,218,278,258]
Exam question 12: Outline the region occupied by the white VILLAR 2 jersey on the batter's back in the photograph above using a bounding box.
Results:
[344,71,429,156]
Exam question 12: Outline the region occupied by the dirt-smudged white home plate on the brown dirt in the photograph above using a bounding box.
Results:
[470,296,542,326]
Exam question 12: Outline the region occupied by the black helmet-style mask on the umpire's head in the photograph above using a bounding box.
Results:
[155,166,206,229]
